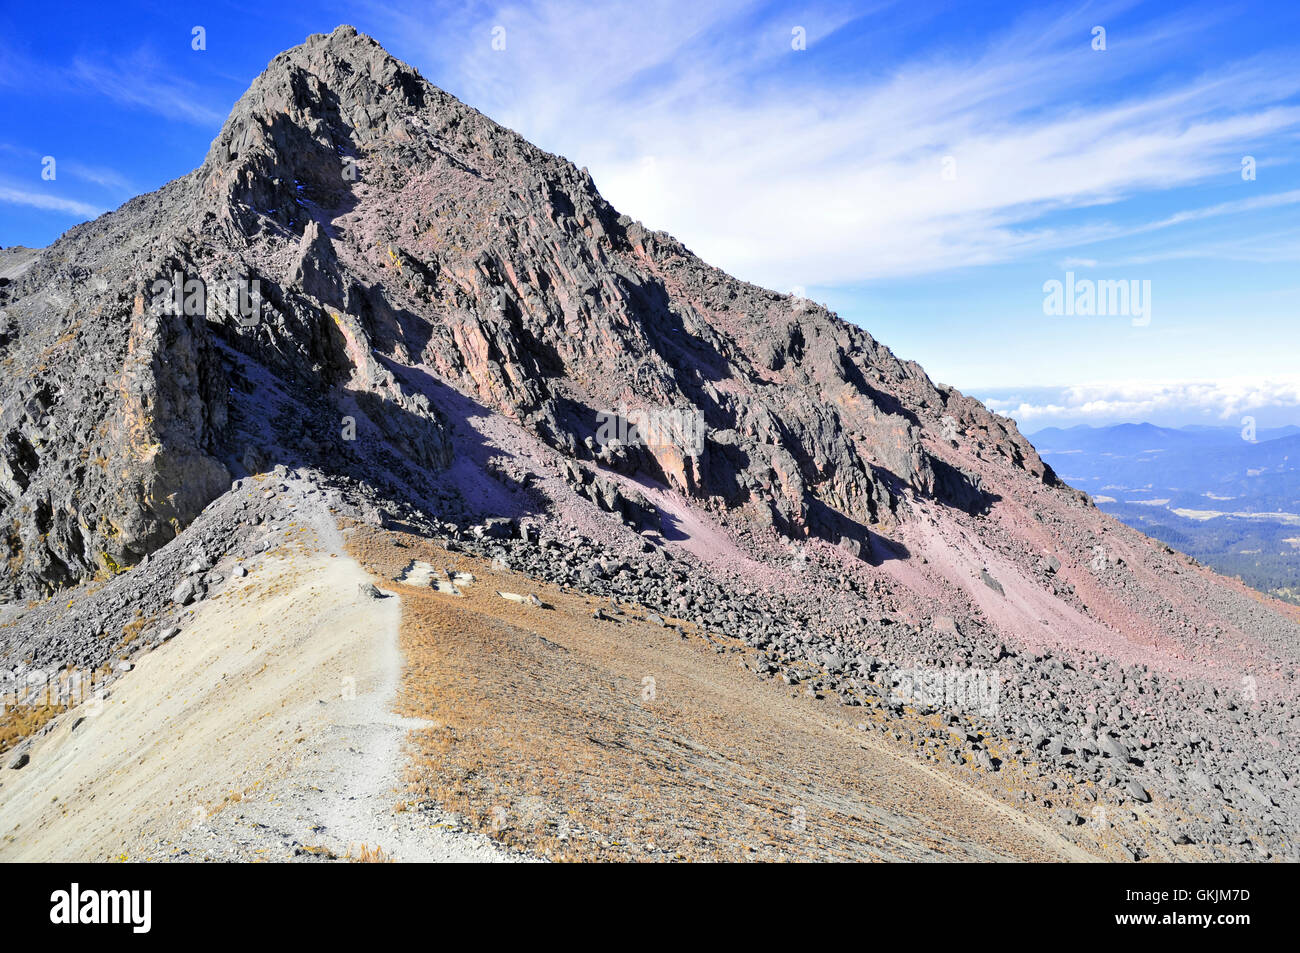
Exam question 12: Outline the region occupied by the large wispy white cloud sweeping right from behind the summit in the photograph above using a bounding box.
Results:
[372,0,1300,287]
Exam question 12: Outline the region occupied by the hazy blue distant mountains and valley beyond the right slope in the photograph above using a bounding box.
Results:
[1032,424,1300,602]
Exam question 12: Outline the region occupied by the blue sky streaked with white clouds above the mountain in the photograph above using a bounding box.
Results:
[0,0,1300,432]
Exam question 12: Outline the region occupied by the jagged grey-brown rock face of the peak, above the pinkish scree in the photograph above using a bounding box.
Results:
[0,27,1054,597]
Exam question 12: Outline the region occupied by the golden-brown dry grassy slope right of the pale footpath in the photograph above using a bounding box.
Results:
[348,527,1078,861]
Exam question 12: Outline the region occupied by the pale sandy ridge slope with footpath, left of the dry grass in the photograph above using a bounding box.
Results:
[0,483,517,861]
